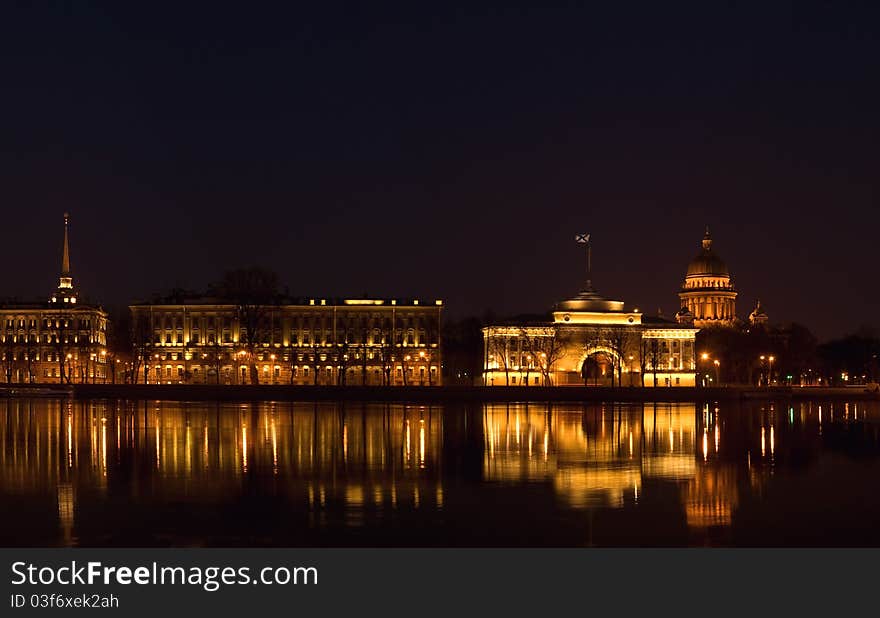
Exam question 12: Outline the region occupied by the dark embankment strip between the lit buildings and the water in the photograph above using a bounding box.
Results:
[0,384,880,403]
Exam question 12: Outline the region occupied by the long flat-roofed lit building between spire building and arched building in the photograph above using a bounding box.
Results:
[130,295,443,386]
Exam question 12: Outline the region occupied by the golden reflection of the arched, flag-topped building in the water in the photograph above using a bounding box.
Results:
[483,404,696,508]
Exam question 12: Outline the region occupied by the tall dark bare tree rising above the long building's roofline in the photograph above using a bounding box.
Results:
[217,267,278,384]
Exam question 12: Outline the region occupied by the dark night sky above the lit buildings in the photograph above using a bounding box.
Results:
[0,1,880,339]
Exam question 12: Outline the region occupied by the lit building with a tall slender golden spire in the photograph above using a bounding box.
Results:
[0,213,108,384]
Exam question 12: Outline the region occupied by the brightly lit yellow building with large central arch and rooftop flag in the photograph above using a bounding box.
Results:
[483,237,698,386]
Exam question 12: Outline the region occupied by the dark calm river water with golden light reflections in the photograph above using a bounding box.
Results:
[0,399,880,547]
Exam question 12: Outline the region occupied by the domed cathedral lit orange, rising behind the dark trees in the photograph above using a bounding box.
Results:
[676,227,737,328]
